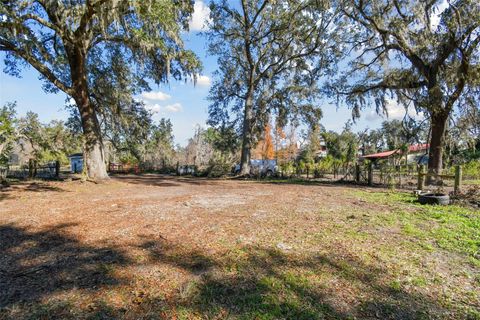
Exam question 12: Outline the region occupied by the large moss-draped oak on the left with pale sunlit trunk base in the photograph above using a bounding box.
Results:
[0,0,199,179]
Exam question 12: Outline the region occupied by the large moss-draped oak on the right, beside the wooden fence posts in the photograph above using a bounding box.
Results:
[334,0,480,173]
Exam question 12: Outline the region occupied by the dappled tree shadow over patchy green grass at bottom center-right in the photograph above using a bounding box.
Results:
[136,241,455,320]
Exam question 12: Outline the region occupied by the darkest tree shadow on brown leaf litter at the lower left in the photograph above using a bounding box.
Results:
[0,224,129,308]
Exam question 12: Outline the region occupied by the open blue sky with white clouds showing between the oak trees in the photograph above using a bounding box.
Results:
[0,1,412,145]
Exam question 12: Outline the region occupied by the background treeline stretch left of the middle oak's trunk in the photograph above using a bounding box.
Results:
[0,103,239,176]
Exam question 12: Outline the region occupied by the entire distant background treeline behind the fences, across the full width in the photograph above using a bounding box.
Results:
[0,99,480,176]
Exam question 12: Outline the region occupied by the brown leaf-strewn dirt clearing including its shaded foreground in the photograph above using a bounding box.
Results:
[0,175,480,319]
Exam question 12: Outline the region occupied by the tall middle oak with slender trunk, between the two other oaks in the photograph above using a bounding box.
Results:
[207,0,338,174]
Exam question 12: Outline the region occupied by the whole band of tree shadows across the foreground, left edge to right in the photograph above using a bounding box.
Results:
[0,225,466,320]
